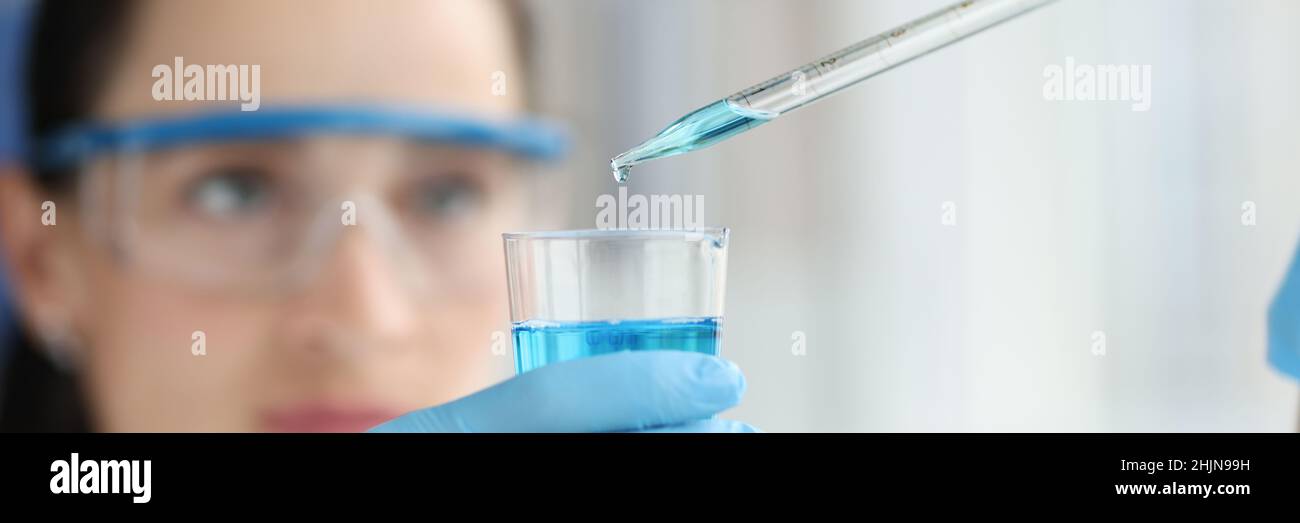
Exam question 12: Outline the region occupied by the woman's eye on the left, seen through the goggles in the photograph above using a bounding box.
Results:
[186,167,270,219]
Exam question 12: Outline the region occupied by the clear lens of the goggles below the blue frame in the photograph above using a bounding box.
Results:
[79,137,517,297]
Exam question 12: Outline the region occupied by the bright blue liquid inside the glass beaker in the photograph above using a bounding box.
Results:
[511,317,722,373]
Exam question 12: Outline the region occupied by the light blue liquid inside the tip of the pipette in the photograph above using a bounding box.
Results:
[610,100,776,183]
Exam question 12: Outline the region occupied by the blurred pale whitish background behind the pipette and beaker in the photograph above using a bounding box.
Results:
[0,0,1300,432]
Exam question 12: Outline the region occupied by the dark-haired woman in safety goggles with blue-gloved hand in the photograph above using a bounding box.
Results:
[0,0,750,432]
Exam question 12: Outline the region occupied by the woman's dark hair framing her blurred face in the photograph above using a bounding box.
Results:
[0,0,532,432]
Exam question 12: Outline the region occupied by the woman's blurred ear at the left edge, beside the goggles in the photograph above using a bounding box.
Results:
[0,167,84,343]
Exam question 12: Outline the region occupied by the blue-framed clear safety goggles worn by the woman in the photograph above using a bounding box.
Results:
[34,107,566,294]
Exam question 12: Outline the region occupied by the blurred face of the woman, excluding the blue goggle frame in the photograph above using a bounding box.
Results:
[26,0,533,431]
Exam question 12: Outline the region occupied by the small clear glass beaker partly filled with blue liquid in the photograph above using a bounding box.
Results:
[503,229,729,373]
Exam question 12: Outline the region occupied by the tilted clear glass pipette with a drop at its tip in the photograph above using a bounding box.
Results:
[610,0,1056,183]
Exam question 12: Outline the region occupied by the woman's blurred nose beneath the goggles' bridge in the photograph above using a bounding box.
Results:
[286,208,419,353]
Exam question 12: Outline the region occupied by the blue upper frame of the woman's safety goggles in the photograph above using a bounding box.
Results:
[30,105,568,169]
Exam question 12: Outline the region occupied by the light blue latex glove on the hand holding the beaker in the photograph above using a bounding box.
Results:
[371,350,757,432]
